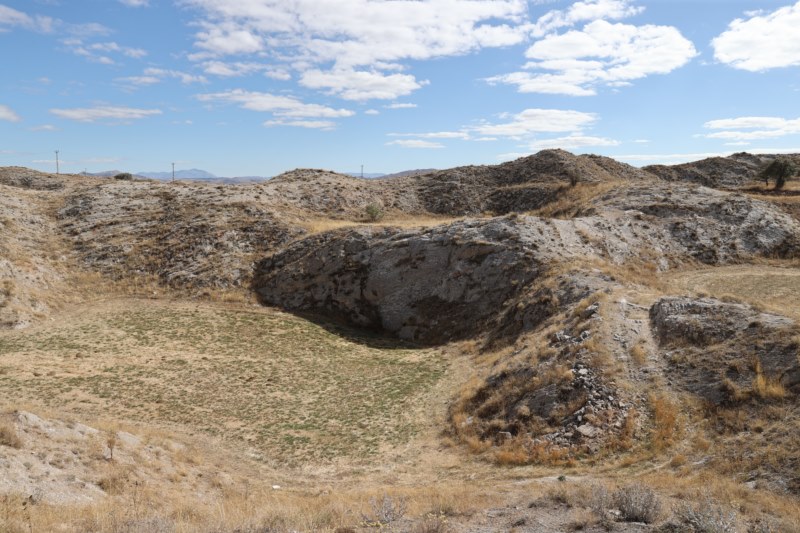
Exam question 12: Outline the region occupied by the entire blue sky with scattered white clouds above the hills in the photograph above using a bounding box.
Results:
[0,0,800,176]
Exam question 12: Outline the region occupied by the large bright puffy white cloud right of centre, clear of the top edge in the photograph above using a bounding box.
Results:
[487,20,697,96]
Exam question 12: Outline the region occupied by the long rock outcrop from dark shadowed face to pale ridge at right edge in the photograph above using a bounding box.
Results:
[254,182,800,342]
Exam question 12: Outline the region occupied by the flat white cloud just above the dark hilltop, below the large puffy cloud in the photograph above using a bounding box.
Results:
[470,108,597,137]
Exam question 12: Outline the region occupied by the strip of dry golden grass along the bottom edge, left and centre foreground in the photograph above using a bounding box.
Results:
[0,482,498,533]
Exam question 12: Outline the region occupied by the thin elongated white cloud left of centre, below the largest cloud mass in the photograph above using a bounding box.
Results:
[197,89,355,118]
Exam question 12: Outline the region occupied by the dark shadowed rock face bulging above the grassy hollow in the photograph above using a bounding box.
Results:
[255,219,552,342]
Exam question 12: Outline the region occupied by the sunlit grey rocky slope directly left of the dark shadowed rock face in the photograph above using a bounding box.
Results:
[58,182,303,289]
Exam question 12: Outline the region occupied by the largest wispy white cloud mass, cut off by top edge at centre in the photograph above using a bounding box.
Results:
[184,0,529,100]
